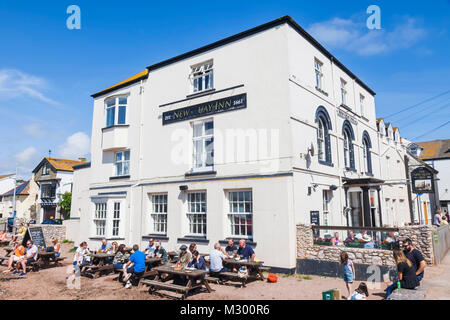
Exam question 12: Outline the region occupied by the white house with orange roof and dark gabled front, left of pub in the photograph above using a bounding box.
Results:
[33,157,86,222]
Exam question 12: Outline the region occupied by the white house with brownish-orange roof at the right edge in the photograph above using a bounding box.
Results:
[416,139,450,213]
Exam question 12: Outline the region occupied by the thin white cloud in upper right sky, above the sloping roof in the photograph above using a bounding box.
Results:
[308,17,426,56]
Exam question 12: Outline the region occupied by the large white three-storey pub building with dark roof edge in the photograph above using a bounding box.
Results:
[68,17,408,271]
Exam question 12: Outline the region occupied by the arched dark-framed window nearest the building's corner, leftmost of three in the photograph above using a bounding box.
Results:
[316,106,332,165]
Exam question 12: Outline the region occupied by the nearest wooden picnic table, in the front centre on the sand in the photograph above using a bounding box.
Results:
[142,265,214,300]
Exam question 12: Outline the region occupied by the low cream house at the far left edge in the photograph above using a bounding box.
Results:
[2,179,38,221]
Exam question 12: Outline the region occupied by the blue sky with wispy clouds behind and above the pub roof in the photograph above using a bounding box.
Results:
[0,0,450,176]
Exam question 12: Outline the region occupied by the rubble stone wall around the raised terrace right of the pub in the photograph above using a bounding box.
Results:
[297,225,434,266]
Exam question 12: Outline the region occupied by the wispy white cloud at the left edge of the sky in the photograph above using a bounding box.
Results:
[0,69,59,105]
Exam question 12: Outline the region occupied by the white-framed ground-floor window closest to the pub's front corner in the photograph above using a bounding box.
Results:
[226,189,254,239]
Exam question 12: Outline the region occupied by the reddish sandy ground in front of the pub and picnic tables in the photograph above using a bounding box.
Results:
[0,244,450,300]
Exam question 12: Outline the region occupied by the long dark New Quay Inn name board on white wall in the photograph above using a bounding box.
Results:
[163,93,247,125]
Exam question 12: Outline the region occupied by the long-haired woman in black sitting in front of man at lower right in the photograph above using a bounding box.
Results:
[386,249,420,298]
